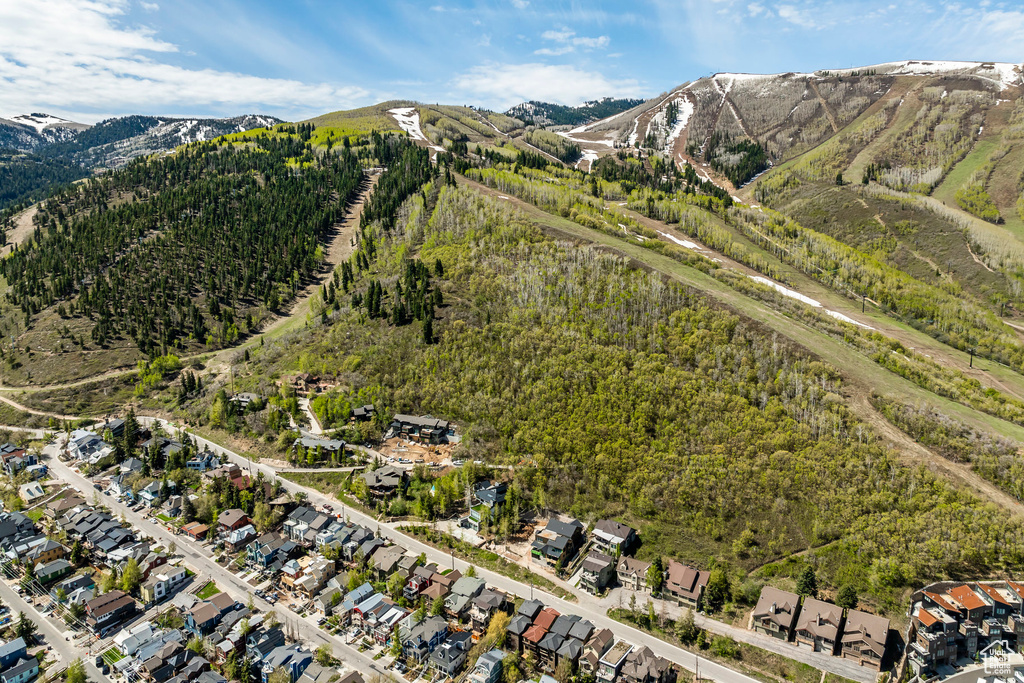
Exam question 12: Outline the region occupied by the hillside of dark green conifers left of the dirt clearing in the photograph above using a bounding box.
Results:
[0,136,368,382]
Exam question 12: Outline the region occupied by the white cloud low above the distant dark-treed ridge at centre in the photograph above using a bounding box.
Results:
[452,63,646,110]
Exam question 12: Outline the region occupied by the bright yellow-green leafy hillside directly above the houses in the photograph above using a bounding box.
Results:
[205,176,1024,614]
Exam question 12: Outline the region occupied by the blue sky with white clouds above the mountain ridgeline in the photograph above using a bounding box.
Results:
[0,0,1024,122]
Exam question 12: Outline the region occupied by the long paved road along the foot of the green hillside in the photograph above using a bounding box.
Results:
[134,417,756,683]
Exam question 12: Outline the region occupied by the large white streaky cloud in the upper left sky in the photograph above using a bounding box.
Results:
[0,0,369,120]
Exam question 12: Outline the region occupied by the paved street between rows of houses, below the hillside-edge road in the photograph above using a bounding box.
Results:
[43,444,387,676]
